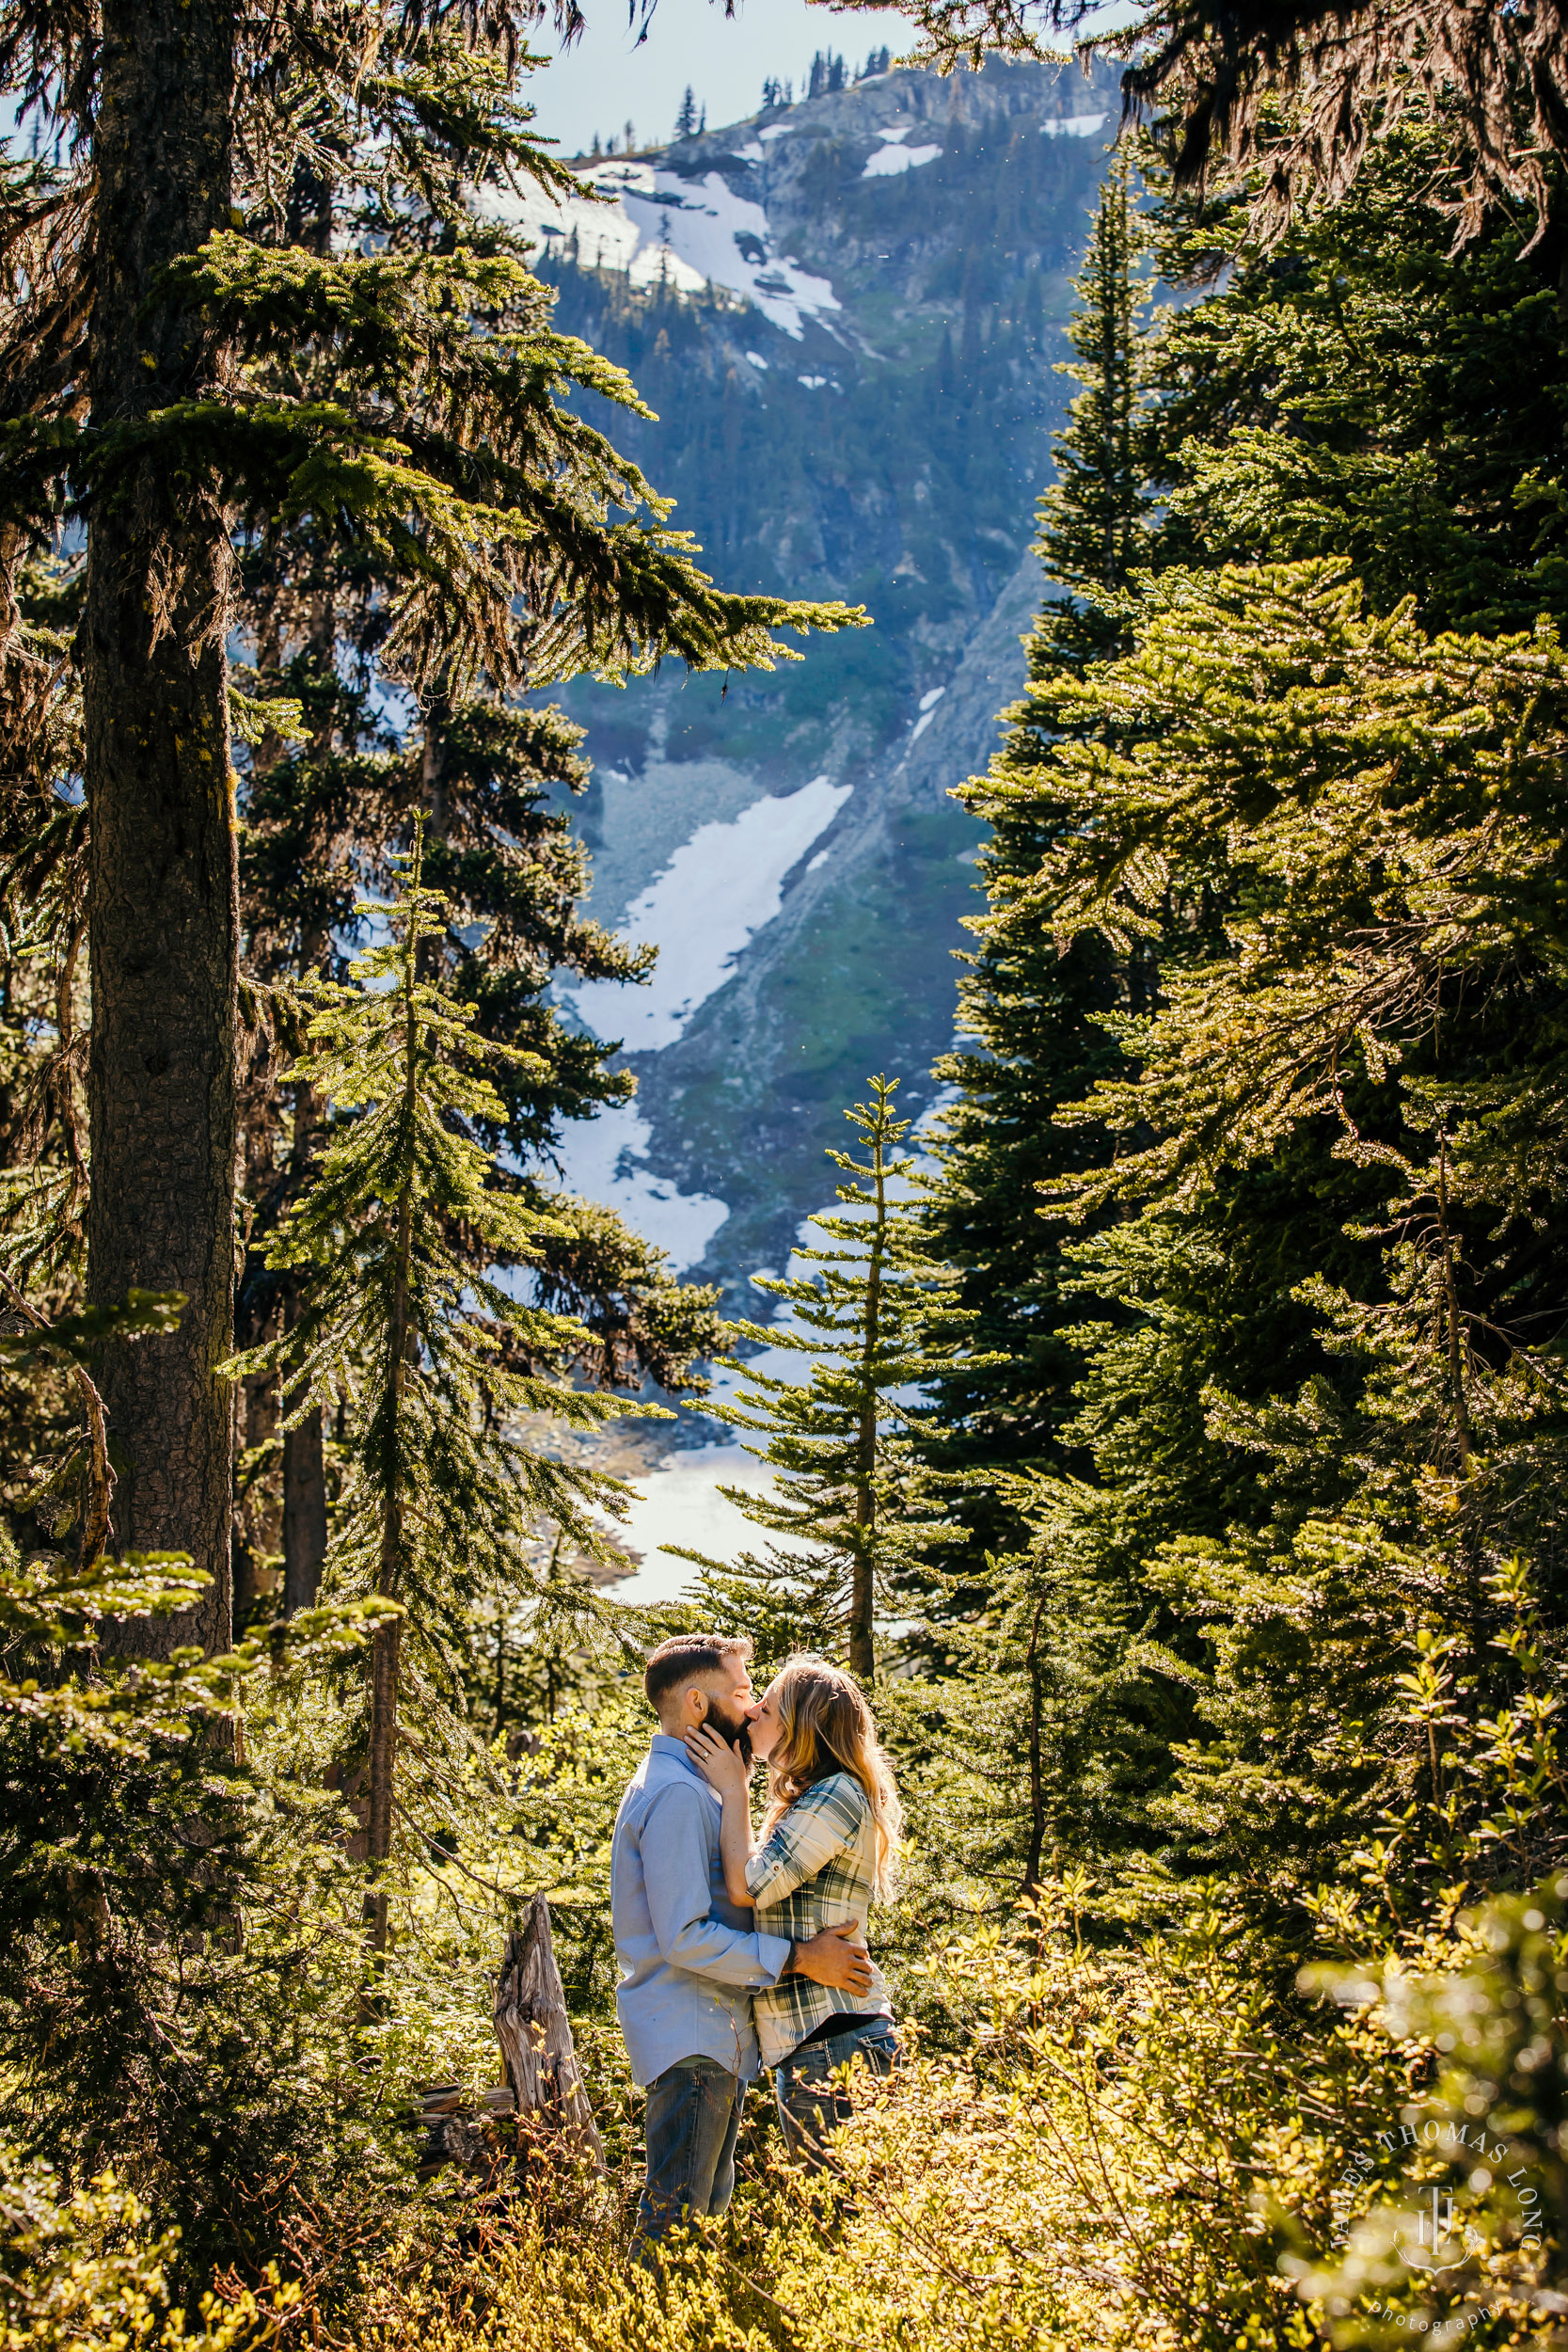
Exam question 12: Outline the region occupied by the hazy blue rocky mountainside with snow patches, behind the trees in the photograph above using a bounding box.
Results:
[500,64,1117,1306]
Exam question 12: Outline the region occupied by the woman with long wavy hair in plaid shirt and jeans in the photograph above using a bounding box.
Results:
[687,1659,903,2167]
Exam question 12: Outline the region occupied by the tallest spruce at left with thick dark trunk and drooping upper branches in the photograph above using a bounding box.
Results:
[0,18,848,1646]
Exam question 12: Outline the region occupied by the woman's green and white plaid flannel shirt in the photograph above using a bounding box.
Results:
[745,1772,894,2065]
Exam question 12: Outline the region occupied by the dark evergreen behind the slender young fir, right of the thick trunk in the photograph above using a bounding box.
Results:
[240,663,717,1612]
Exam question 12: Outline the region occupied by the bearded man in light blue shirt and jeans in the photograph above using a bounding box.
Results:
[609,1635,872,2251]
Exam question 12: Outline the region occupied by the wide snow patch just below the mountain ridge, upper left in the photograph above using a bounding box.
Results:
[491,158,842,342]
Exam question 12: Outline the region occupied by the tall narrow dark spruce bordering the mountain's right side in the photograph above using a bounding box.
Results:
[928,153,1149,1569]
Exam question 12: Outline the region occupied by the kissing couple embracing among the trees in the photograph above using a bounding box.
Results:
[609,1635,903,2258]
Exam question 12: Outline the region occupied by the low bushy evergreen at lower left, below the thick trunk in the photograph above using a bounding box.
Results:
[0,1534,411,2303]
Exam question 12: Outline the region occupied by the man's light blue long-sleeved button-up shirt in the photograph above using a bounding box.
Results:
[609,1731,790,2084]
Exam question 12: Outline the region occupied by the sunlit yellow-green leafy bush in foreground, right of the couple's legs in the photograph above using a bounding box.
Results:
[367,1889,1559,2352]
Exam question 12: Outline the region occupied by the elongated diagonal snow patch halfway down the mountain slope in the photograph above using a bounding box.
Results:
[576,776,851,1054]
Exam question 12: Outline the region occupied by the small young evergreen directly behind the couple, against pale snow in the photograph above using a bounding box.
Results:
[679,1077,969,1689]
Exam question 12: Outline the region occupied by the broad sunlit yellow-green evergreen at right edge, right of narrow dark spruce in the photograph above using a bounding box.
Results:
[991,563,1568,1927]
